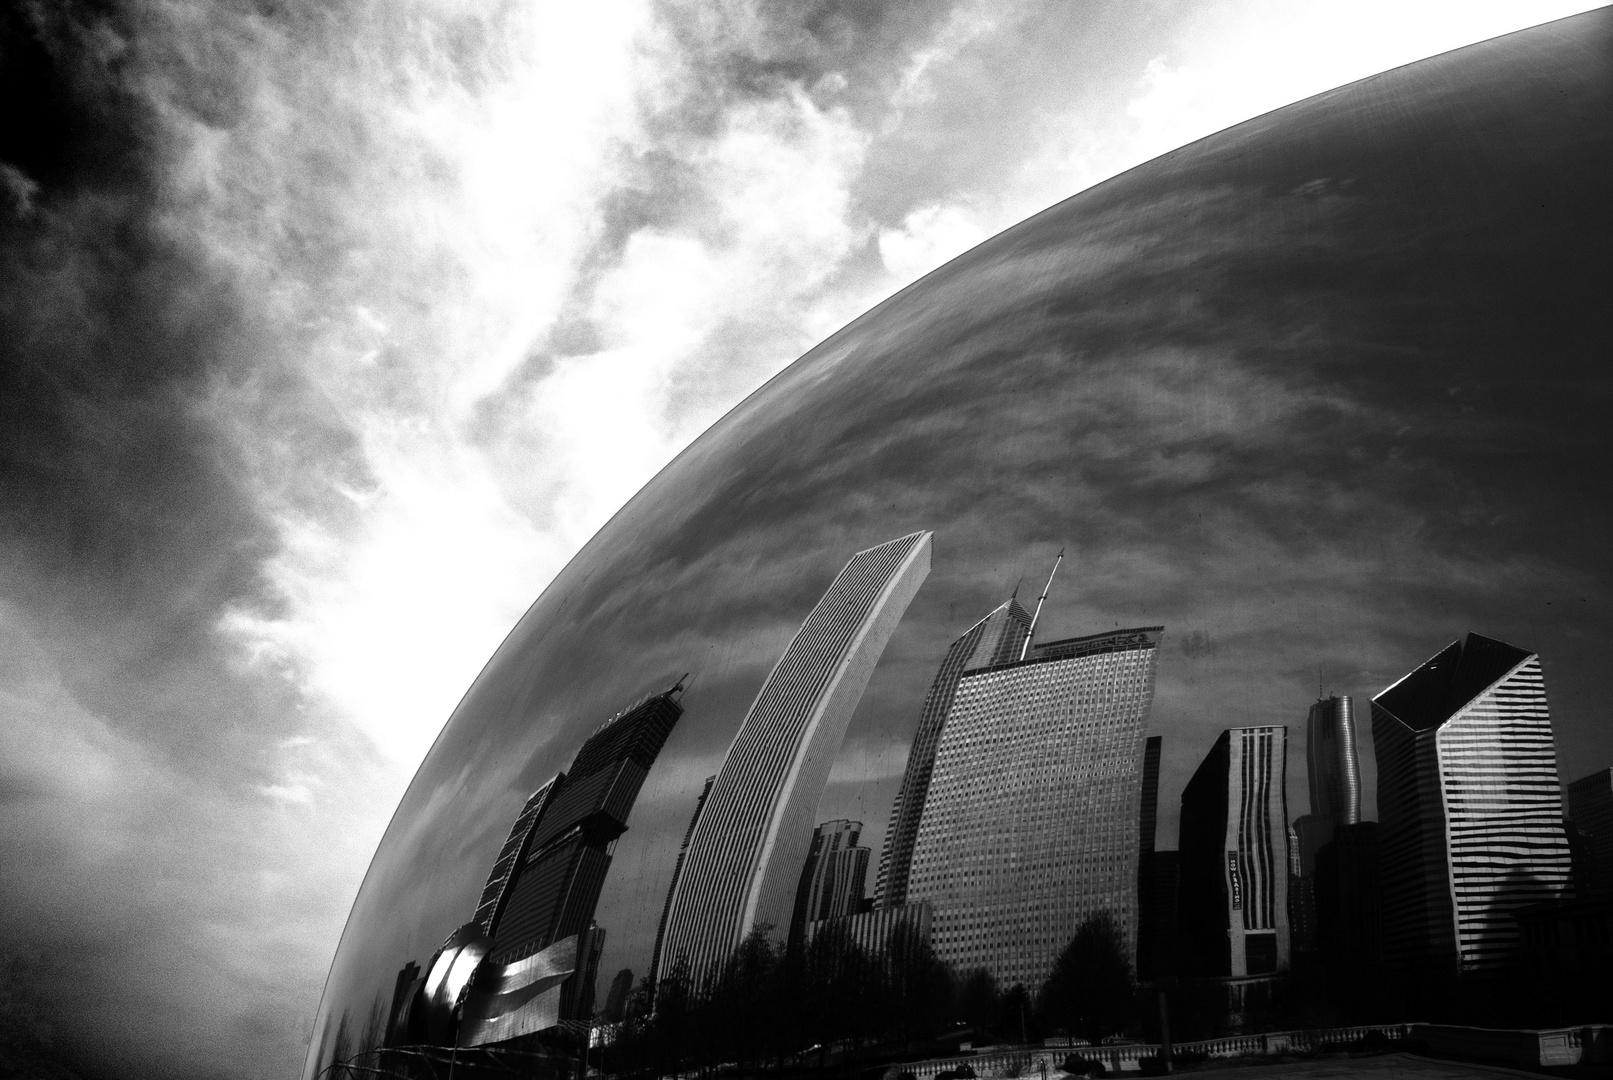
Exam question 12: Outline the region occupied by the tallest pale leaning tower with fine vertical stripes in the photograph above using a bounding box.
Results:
[661,532,931,987]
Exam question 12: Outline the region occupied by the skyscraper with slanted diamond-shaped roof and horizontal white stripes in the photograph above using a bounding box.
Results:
[1373,633,1571,970]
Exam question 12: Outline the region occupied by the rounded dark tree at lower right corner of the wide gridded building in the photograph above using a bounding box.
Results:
[1037,911,1136,1046]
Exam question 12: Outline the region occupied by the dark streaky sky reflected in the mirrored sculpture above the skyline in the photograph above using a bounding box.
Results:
[303,10,1613,1076]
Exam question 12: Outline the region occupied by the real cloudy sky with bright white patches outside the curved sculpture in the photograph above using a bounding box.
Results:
[0,2,1594,1077]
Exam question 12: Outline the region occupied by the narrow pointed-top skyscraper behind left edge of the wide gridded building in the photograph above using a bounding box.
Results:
[874,596,1031,908]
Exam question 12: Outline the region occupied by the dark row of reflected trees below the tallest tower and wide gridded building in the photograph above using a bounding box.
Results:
[595,912,1137,1077]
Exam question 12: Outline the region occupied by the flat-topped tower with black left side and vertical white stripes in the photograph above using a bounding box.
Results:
[1177,727,1289,977]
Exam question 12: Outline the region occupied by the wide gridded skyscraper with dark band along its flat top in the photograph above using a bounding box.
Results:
[908,627,1163,988]
